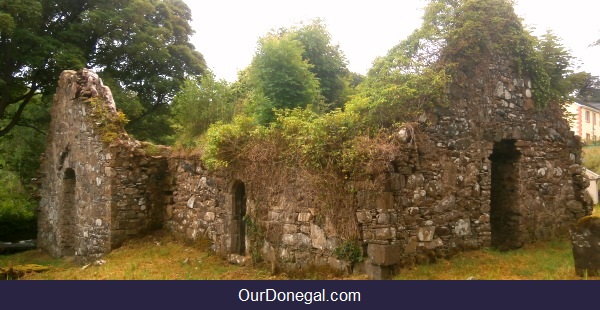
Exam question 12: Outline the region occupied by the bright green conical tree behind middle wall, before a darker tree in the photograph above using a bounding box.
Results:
[249,34,320,124]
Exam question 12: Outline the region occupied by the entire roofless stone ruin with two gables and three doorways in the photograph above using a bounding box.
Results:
[38,50,591,279]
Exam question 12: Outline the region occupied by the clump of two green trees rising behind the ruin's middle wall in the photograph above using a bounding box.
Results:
[236,20,355,125]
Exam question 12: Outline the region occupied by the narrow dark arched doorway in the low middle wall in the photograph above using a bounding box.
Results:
[230,181,246,255]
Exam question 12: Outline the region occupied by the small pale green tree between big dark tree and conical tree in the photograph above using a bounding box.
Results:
[173,72,234,143]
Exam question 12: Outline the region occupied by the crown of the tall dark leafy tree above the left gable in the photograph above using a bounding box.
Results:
[0,0,205,138]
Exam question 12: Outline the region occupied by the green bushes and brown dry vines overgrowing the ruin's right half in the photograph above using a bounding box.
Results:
[196,0,584,259]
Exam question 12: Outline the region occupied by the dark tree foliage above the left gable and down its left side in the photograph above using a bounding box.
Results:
[0,0,205,241]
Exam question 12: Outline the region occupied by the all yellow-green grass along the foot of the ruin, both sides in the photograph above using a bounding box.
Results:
[0,226,600,280]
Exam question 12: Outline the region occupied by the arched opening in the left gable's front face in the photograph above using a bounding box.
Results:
[60,168,77,256]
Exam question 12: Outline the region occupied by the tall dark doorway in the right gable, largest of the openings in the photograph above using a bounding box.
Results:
[489,140,523,250]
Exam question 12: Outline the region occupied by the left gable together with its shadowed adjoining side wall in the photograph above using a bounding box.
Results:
[38,70,170,260]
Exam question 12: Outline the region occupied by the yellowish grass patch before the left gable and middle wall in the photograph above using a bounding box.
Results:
[0,233,364,280]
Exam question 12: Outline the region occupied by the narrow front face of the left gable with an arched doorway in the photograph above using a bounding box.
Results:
[38,71,112,256]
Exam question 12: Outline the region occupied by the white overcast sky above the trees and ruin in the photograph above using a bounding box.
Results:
[184,0,600,82]
